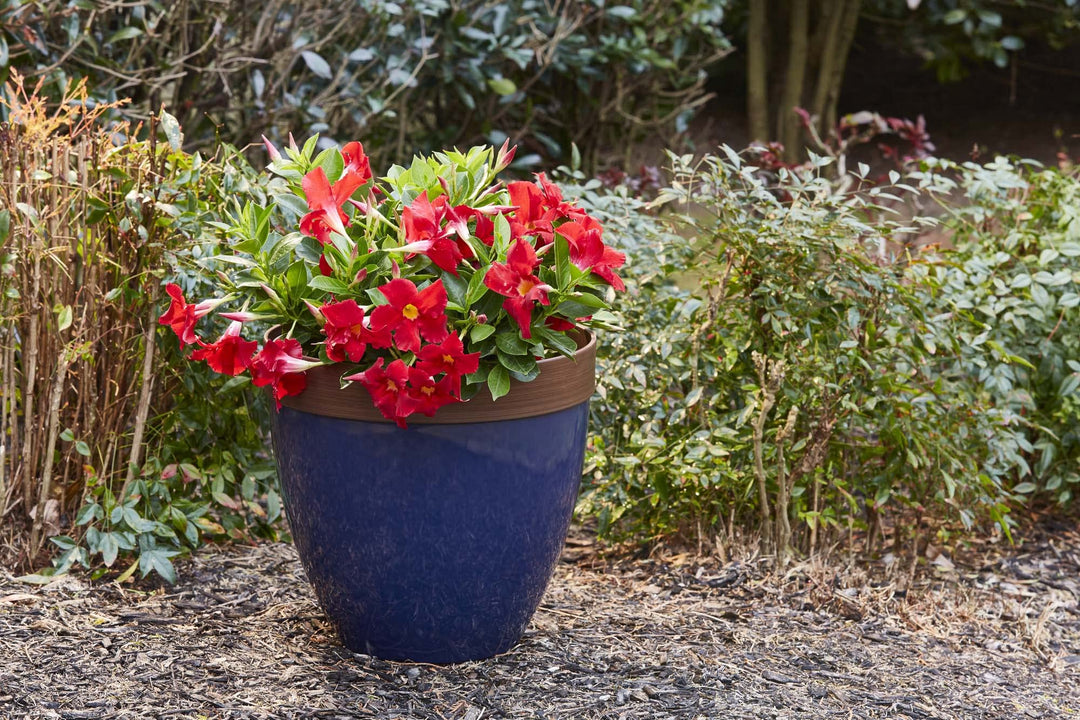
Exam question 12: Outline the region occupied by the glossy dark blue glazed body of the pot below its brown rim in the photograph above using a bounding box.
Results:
[273,402,589,663]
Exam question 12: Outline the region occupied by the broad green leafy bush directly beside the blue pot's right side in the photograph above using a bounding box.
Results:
[581,151,1025,554]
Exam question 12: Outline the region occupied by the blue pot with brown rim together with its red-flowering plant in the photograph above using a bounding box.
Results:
[161,138,624,663]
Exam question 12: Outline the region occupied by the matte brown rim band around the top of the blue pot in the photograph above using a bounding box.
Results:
[281,332,596,424]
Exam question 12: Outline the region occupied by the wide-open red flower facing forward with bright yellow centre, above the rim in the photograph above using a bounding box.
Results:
[372,277,449,353]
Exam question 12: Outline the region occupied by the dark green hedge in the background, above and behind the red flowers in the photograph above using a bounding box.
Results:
[0,0,727,166]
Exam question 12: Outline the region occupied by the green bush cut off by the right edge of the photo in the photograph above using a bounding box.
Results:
[917,158,1080,504]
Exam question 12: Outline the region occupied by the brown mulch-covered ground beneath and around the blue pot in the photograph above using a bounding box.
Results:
[0,527,1080,720]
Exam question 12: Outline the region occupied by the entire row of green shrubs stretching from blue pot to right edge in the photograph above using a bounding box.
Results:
[581,151,1080,556]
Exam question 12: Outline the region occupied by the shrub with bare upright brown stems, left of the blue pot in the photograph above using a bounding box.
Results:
[0,77,280,580]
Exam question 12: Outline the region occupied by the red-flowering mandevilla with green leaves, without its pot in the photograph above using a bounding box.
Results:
[160,137,625,427]
